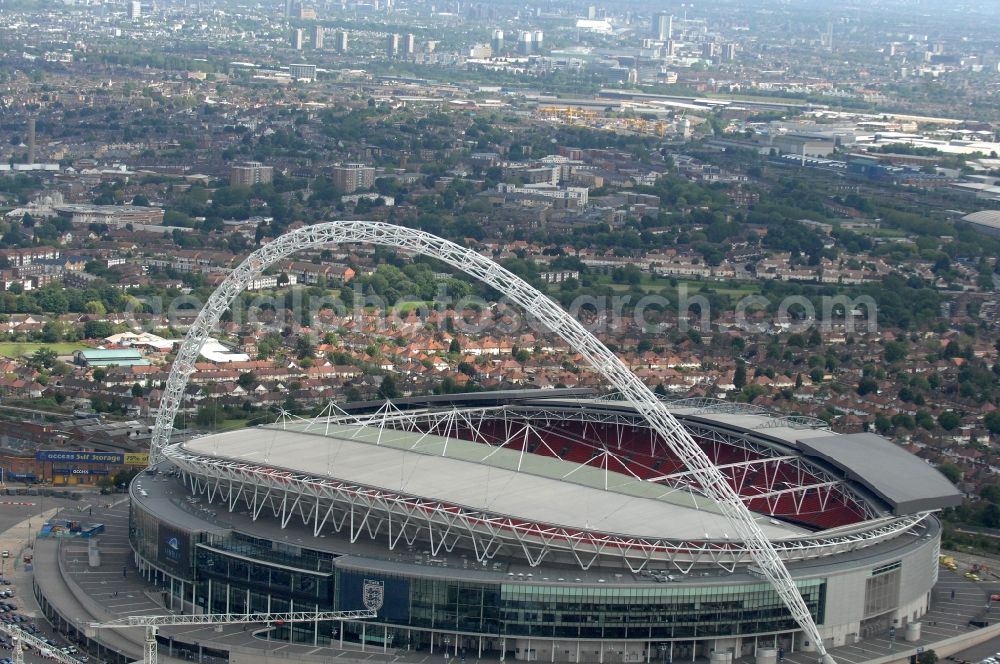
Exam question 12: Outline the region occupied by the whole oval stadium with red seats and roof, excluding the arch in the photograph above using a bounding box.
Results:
[130,390,960,662]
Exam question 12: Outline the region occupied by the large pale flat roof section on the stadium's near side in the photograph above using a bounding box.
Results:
[182,422,808,540]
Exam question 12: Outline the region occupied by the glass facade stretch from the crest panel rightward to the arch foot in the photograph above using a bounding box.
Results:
[334,570,826,639]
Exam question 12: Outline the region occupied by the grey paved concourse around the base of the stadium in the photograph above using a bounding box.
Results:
[11,497,1000,664]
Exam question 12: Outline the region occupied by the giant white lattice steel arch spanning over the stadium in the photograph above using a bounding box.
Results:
[149,221,833,663]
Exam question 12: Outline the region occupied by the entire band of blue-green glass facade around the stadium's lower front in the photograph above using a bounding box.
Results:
[130,498,828,647]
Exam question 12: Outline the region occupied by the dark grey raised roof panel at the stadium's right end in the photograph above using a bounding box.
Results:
[798,433,962,514]
